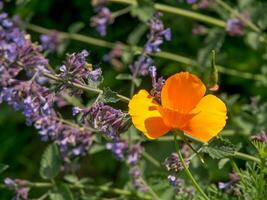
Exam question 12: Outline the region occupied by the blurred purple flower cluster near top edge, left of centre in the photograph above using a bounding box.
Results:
[91,7,113,36]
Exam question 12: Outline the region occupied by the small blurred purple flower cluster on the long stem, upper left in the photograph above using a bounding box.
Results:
[40,31,61,52]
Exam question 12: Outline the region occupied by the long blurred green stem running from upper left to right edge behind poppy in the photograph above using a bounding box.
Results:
[27,24,265,82]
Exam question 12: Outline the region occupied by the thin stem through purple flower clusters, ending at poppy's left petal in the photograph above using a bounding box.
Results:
[43,72,130,103]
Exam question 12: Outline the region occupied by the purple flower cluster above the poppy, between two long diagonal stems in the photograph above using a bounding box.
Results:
[144,13,171,53]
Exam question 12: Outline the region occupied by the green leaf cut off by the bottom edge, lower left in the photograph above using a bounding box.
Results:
[49,183,73,200]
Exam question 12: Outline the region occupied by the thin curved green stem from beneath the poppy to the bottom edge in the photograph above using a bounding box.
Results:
[173,133,209,200]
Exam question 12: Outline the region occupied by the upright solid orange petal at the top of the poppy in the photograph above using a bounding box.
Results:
[161,72,206,113]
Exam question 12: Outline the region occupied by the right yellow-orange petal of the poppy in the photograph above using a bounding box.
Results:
[183,95,227,142]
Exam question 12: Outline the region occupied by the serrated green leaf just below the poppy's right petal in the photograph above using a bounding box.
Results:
[203,138,236,159]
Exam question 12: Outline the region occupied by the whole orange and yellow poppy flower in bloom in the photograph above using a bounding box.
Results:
[129,72,227,142]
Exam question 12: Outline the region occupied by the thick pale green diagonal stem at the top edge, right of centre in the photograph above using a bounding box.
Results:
[109,0,225,28]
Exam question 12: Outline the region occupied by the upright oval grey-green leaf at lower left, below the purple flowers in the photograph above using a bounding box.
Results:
[40,144,61,179]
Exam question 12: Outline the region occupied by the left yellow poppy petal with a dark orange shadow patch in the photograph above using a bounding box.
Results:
[129,90,170,139]
